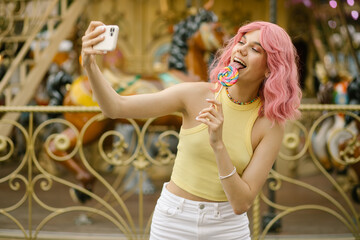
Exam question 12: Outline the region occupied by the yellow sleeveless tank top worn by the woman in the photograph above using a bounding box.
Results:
[171,89,261,201]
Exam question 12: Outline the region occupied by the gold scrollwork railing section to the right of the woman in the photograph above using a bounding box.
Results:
[253,105,360,239]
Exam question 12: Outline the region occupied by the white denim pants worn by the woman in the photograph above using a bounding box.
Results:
[150,183,251,240]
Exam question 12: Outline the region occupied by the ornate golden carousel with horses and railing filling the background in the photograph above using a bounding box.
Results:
[0,0,360,240]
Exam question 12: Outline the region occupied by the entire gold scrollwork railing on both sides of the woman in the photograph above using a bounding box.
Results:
[0,105,360,239]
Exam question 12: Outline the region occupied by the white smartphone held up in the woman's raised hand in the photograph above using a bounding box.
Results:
[93,25,119,51]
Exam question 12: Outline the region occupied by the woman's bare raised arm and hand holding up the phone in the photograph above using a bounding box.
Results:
[81,21,188,118]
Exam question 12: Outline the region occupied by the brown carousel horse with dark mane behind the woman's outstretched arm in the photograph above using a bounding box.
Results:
[45,10,225,203]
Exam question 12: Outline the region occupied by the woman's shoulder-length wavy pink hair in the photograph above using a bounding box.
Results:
[210,21,302,124]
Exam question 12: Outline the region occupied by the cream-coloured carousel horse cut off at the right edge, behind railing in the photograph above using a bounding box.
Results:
[312,72,360,203]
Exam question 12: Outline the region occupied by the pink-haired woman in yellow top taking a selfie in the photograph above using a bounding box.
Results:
[82,19,301,240]
